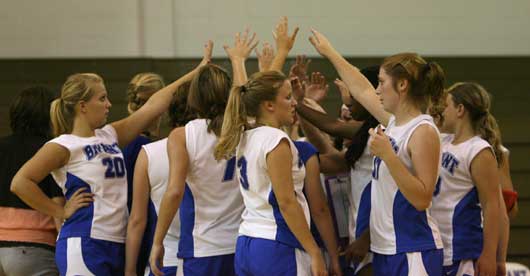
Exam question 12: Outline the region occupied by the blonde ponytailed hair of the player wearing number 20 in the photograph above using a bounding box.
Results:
[50,73,103,136]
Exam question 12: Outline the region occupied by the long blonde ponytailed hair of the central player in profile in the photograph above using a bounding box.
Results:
[214,71,287,160]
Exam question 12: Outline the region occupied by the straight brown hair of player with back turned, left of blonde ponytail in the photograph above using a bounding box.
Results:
[188,63,232,137]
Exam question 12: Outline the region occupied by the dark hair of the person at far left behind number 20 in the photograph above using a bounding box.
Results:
[9,86,55,137]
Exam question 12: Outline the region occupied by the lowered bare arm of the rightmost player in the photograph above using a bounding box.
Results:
[470,149,501,275]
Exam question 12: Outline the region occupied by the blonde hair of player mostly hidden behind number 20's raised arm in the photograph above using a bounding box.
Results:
[127,73,165,114]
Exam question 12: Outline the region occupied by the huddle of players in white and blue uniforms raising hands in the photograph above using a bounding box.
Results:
[12,18,508,275]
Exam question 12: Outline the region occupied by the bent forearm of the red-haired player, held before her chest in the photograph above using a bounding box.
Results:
[384,154,434,211]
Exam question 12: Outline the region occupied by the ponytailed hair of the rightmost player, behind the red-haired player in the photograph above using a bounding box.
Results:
[447,82,504,166]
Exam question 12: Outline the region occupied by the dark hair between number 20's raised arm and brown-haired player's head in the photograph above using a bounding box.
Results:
[168,82,197,128]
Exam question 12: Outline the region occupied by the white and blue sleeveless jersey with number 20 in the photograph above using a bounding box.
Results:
[48,125,128,243]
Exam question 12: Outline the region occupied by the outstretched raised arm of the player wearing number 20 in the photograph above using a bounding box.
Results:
[112,40,213,147]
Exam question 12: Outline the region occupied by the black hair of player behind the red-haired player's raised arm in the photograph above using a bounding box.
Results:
[345,66,379,168]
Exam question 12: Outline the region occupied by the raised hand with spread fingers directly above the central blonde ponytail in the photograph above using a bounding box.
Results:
[223,28,259,86]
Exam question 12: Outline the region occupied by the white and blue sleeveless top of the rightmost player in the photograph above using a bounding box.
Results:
[431,136,492,265]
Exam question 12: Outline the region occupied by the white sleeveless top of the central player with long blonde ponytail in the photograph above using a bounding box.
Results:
[236,126,310,248]
